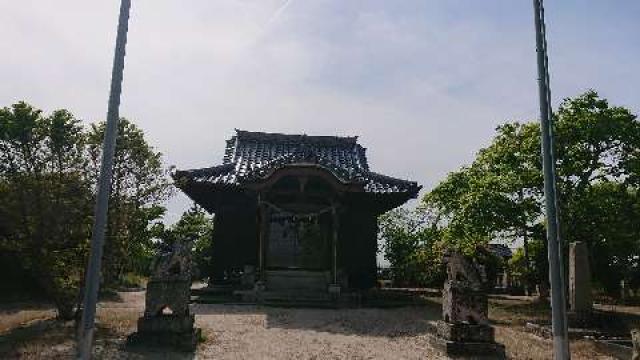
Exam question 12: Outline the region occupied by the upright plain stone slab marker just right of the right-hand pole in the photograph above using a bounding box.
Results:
[569,241,593,315]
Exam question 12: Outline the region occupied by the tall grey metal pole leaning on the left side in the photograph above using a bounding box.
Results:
[77,0,131,360]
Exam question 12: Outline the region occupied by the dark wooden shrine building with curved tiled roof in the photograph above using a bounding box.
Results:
[173,130,421,292]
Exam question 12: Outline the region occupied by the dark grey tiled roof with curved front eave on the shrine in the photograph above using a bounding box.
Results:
[175,130,420,197]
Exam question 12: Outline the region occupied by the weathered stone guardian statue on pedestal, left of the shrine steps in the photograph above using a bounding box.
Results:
[128,241,200,351]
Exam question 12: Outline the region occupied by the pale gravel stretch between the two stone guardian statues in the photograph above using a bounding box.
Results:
[194,305,443,359]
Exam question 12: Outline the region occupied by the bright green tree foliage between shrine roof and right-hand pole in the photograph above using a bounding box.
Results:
[423,123,542,249]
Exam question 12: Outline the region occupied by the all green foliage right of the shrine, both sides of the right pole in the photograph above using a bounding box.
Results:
[423,91,640,292]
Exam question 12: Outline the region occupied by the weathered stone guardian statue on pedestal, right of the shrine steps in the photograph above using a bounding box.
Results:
[432,251,505,358]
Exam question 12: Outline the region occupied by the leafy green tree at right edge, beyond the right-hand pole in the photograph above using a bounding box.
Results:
[556,91,640,295]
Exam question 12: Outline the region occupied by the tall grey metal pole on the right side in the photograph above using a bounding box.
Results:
[533,0,571,360]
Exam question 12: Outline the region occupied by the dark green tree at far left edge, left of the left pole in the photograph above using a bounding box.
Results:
[0,102,92,319]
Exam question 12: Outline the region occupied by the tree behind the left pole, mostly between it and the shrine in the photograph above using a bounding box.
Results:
[87,118,172,285]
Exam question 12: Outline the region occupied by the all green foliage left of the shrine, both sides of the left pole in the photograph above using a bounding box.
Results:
[0,102,169,319]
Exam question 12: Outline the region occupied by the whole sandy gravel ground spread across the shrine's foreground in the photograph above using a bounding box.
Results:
[0,292,624,360]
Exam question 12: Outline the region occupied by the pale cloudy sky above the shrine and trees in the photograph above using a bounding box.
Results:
[0,0,640,222]
